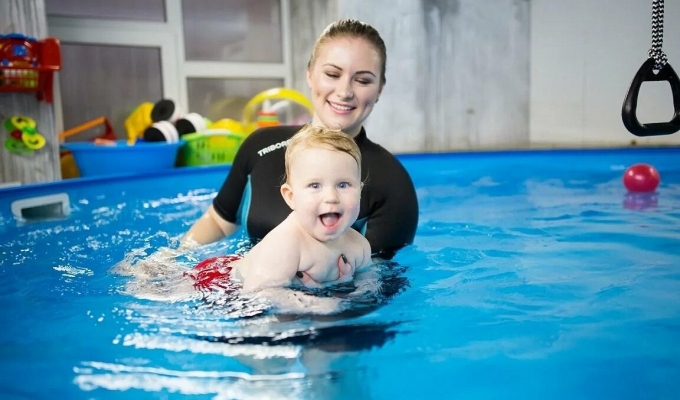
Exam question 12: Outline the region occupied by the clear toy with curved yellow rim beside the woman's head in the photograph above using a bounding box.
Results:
[242,88,314,134]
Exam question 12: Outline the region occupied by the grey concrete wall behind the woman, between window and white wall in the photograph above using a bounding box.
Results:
[291,0,530,152]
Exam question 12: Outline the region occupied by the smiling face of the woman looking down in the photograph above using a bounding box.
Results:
[307,38,382,137]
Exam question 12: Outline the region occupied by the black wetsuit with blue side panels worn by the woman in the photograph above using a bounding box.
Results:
[213,126,418,259]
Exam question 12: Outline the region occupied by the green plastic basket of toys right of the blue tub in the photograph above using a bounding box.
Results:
[180,129,246,167]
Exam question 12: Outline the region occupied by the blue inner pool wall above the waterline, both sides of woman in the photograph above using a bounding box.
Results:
[0,147,680,225]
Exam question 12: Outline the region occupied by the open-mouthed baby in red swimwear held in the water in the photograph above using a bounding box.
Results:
[186,125,371,291]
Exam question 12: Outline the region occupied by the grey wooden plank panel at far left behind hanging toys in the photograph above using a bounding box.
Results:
[0,0,61,184]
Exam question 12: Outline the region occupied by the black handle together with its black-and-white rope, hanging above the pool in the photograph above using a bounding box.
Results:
[621,0,680,136]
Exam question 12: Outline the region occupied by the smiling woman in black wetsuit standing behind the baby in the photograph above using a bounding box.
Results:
[182,19,418,263]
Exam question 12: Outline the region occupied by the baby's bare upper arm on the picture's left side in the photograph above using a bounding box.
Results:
[241,231,300,291]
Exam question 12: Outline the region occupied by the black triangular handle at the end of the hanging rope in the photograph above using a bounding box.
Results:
[621,57,680,136]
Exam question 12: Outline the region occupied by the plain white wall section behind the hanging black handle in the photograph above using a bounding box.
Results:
[530,0,680,146]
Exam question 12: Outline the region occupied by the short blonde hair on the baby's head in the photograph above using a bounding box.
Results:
[284,124,361,182]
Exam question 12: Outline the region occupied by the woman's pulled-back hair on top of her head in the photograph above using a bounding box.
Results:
[307,19,387,86]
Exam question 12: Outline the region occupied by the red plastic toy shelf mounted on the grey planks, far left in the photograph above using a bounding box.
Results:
[0,33,61,103]
